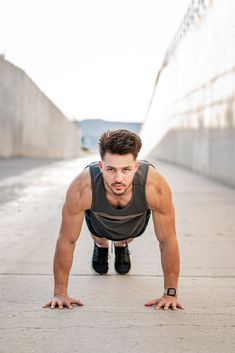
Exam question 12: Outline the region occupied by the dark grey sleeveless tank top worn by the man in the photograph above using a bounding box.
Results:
[86,161,150,240]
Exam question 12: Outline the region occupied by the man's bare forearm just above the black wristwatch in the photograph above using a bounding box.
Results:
[160,239,180,288]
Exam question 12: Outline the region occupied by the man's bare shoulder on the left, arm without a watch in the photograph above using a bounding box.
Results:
[65,168,92,213]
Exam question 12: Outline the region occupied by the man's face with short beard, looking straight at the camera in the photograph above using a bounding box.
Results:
[99,152,139,196]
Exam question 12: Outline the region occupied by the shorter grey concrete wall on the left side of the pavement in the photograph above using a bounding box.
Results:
[0,55,80,158]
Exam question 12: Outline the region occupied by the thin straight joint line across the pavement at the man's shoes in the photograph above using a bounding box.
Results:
[0,272,235,279]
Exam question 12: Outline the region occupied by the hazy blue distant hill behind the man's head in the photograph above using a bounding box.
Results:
[75,119,142,151]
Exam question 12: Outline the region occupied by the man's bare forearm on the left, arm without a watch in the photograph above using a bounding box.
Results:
[53,238,75,296]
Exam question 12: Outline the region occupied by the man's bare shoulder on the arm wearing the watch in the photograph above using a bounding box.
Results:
[146,165,172,210]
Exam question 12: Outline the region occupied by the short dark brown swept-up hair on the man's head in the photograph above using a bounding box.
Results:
[99,129,142,159]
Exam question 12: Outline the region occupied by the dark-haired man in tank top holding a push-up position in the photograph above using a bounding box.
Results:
[44,129,183,310]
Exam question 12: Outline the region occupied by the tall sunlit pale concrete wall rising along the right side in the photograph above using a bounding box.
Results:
[142,0,235,187]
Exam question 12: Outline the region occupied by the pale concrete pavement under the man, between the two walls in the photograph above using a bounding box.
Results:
[0,157,235,353]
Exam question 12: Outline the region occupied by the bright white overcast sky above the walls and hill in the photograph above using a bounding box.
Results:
[0,0,191,122]
